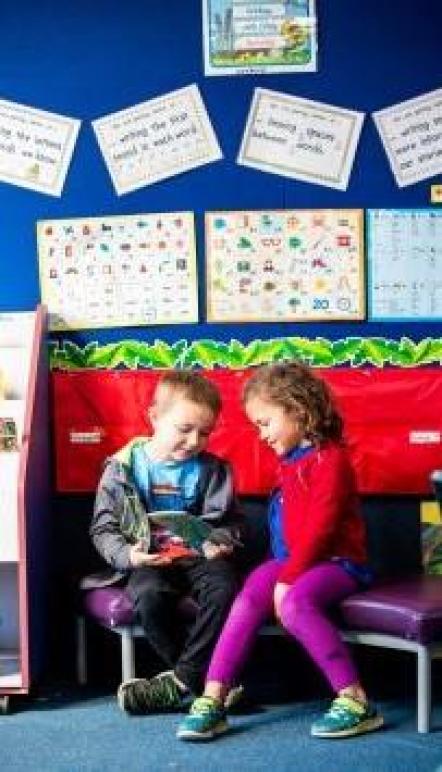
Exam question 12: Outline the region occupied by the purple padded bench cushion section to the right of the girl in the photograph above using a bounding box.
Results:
[341,576,442,644]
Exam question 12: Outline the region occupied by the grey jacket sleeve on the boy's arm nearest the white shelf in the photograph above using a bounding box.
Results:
[89,461,131,571]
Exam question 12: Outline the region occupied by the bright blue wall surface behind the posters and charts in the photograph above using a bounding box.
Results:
[0,0,442,345]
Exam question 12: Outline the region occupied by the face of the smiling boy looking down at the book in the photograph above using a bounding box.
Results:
[149,396,216,461]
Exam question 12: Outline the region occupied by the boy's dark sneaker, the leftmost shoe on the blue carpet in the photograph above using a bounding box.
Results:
[117,670,193,716]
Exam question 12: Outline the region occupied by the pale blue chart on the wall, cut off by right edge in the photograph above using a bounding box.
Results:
[367,209,442,322]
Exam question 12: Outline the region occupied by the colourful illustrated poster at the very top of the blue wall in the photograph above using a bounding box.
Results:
[203,0,317,75]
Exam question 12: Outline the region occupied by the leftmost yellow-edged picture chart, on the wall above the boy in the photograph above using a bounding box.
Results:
[37,212,198,330]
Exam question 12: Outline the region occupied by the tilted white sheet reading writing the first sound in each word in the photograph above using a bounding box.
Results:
[92,84,222,196]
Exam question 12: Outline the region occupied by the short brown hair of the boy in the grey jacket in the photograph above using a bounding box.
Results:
[153,370,222,417]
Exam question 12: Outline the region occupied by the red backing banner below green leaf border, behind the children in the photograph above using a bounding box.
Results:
[52,368,442,494]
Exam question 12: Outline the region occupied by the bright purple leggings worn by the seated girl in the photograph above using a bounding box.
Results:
[206,560,358,692]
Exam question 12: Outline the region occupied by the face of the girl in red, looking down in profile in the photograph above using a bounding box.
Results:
[245,395,304,456]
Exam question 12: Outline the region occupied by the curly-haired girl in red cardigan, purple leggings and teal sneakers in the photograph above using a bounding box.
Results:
[177,363,383,740]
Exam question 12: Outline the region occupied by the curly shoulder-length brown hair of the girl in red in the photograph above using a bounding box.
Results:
[242,362,343,445]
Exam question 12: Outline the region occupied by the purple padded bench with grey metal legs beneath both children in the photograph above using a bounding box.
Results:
[77,575,442,732]
